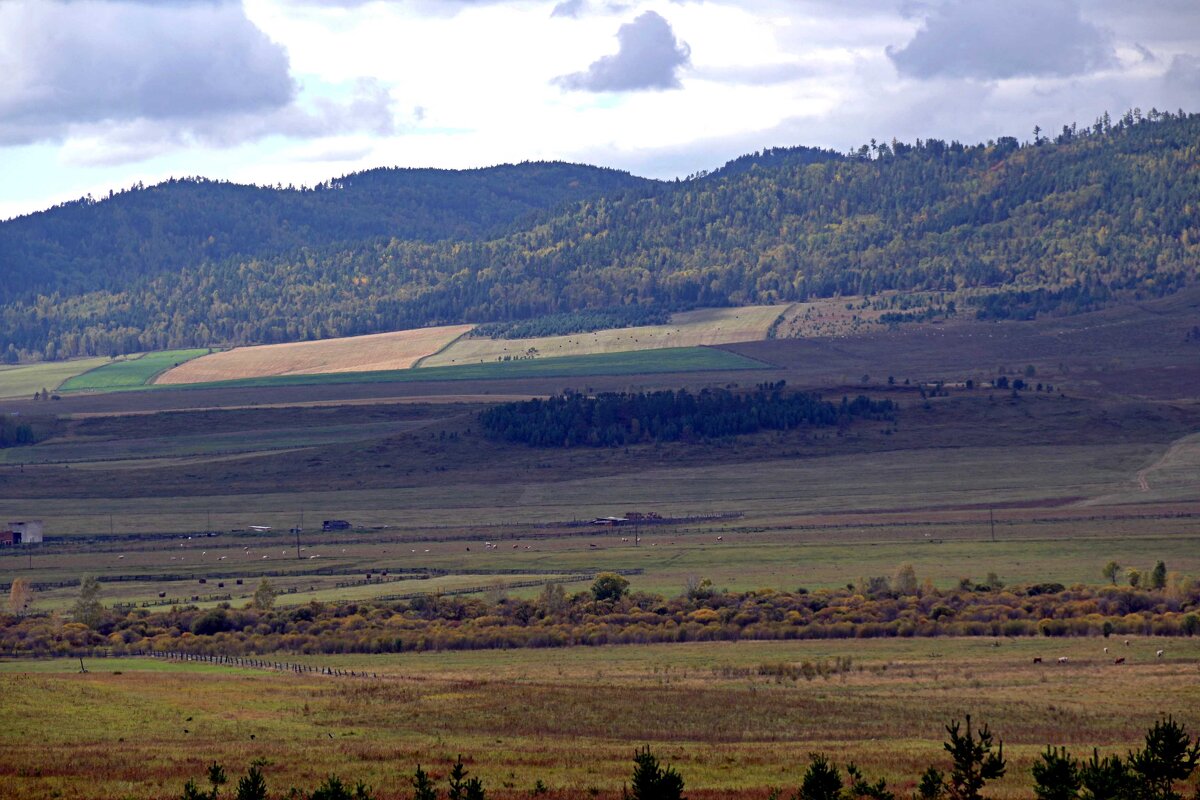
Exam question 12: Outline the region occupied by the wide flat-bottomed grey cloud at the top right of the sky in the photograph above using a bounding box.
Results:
[888,0,1115,80]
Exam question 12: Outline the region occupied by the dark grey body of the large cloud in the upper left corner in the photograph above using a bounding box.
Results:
[0,1,295,143]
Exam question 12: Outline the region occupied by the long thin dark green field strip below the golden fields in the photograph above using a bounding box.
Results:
[75,347,770,391]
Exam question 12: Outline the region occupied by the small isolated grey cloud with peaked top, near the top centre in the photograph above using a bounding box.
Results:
[554,11,691,91]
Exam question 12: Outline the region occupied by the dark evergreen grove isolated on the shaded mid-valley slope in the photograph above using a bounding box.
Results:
[479,381,896,447]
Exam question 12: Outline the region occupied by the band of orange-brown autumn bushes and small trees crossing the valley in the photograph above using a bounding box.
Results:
[0,565,1200,657]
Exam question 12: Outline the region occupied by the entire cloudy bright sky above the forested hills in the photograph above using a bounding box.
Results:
[0,0,1200,218]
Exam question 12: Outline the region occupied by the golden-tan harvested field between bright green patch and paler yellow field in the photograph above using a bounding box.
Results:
[155,325,472,385]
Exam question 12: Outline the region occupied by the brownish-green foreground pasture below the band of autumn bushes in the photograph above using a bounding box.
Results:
[0,638,1200,800]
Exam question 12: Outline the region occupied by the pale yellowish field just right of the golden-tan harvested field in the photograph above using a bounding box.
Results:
[420,306,788,367]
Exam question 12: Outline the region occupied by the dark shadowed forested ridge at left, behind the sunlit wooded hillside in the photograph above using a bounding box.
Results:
[0,162,652,302]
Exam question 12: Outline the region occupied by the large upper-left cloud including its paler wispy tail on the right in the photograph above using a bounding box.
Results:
[0,0,394,155]
